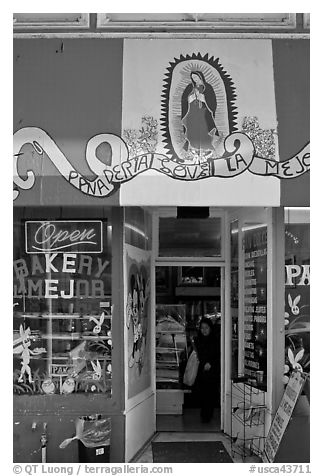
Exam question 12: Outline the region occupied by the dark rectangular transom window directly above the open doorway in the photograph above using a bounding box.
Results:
[159,218,221,258]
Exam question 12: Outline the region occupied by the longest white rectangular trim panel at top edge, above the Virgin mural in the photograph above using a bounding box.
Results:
[96,13,296,31]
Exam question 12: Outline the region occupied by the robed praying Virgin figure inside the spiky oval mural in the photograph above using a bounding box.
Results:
[181,71,219,151]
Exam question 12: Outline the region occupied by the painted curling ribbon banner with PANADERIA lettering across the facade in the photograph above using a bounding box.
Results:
[13,127,310,200]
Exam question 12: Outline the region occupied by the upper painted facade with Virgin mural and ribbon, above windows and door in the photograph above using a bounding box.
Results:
[14,38,309,206]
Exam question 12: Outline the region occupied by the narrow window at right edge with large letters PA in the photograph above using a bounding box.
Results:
[283,216,310,383]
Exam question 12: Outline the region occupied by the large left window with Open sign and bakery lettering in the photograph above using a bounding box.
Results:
[13,208,112,396]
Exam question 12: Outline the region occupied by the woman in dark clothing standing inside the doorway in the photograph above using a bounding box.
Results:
[194,317,220,422]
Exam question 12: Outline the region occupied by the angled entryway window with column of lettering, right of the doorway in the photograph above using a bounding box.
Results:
[230,210,268,391]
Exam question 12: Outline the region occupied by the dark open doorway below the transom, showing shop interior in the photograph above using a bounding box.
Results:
[155,263,224,432]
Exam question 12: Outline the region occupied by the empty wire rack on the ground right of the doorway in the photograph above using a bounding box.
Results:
[231,376,267,460]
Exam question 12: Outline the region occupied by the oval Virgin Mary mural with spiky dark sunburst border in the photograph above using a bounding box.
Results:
[160,53,237,164]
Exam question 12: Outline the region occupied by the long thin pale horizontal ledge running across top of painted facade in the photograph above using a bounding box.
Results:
[13,31,310,40]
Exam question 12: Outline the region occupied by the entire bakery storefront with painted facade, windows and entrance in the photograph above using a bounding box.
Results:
[13,38,310,462]
